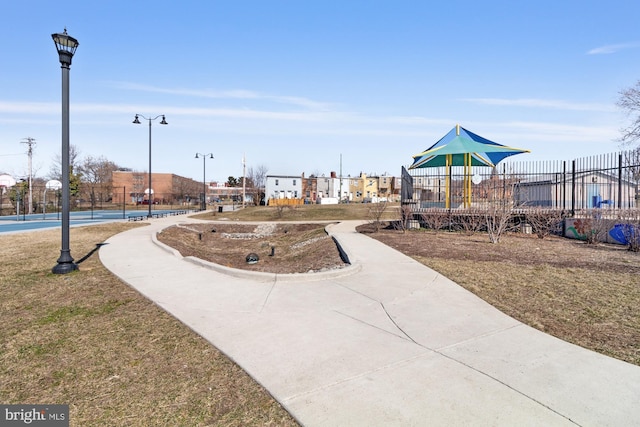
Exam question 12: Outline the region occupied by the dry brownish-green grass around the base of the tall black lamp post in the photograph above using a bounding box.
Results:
[0,223,297,426]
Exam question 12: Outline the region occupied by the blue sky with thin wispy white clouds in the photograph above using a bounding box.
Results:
[0,0,640,181]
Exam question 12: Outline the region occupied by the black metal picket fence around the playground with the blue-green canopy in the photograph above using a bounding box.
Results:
[402,150,640,215]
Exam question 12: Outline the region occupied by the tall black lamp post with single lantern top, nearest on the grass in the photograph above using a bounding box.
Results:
[51,28,78,274]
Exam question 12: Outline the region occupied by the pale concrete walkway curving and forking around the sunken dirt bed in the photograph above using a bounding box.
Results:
[100,217,640,426]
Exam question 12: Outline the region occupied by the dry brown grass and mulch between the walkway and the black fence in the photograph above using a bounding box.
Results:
[368,230,640,365]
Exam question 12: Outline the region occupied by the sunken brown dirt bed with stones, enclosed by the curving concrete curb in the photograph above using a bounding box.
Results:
[158,223,347,274]
